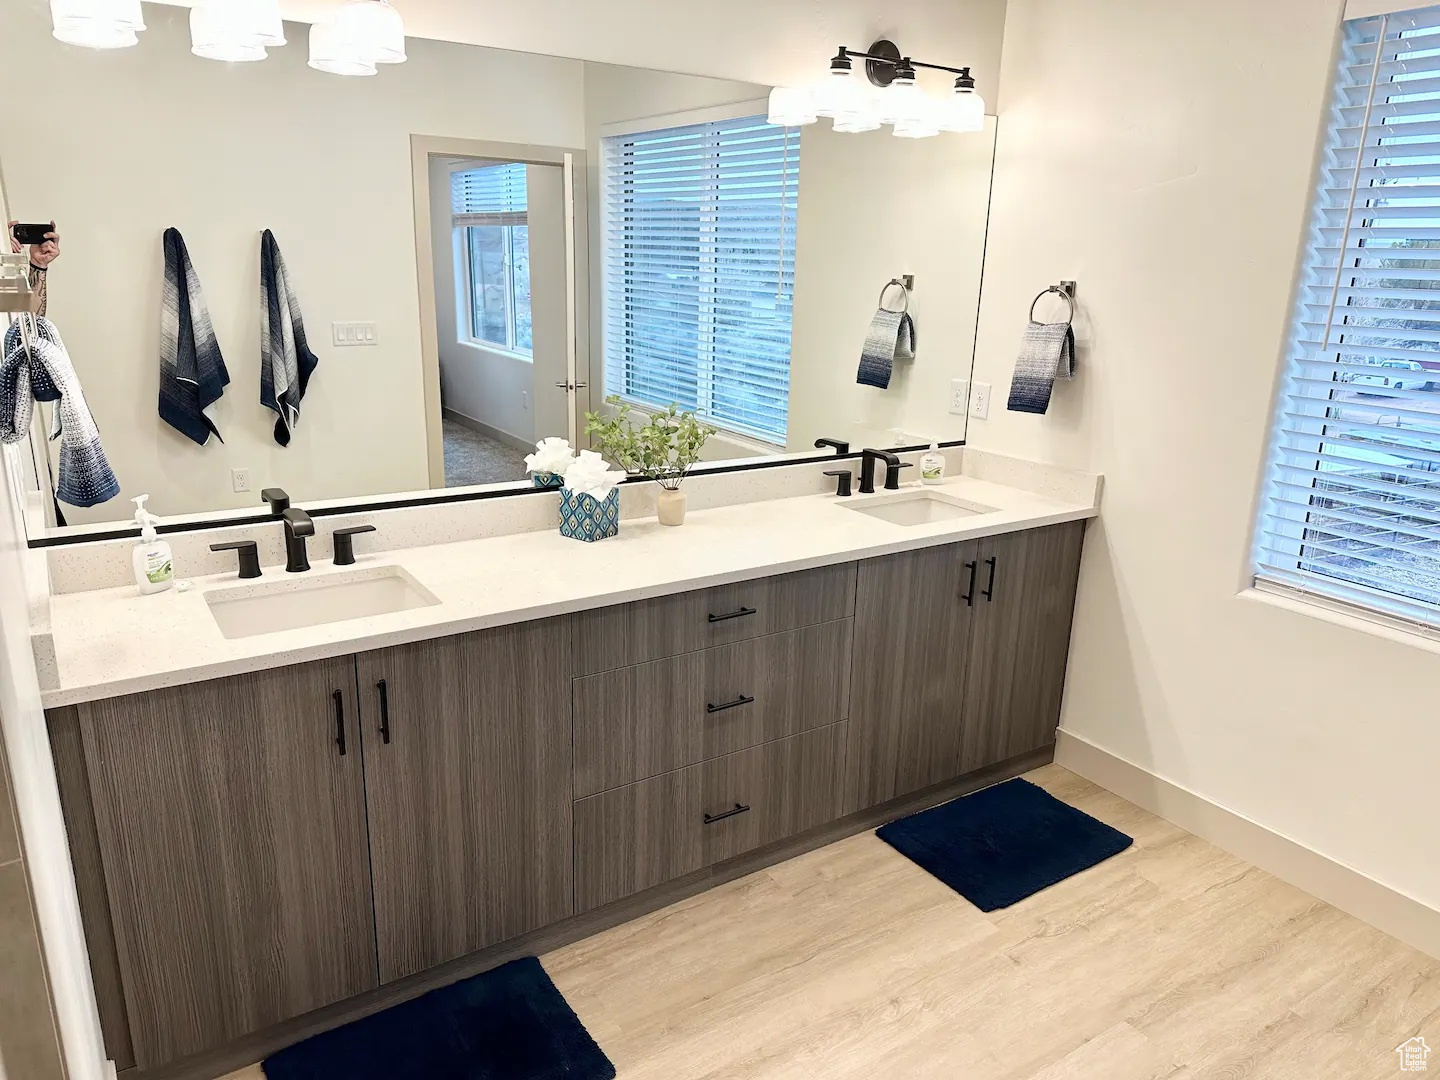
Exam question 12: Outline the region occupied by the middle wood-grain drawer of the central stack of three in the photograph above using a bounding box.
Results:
[573,619,854,798]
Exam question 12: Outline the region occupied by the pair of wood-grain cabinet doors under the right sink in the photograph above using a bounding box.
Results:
[845,521,1084,811]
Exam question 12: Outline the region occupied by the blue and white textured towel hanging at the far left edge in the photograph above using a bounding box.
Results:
[0,315,120,507]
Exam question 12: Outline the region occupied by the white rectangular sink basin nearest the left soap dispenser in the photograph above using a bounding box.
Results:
[204,566,439,638]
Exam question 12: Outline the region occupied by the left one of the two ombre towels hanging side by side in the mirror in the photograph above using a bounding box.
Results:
[160,229,230,446]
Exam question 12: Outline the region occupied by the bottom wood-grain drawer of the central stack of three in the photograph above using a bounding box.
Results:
[575,723,845,912]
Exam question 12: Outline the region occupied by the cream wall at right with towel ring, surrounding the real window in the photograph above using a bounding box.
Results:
[969,0,1440,907]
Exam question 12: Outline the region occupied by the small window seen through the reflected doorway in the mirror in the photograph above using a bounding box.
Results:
[451,163,534,356]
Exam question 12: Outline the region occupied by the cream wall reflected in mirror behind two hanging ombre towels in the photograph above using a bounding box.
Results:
[0,4,583,523]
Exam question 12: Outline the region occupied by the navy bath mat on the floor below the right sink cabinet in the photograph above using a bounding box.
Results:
[876,779,1135,912]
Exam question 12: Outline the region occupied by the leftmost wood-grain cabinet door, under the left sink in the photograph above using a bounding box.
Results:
[78,657,377,1068]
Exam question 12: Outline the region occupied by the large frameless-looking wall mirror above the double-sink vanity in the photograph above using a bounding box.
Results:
[0,3,995,541]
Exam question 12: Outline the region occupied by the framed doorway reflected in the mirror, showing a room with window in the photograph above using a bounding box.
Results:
[412,137,589,488]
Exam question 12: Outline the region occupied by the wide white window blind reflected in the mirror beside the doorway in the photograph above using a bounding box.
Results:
[603,117,799,444]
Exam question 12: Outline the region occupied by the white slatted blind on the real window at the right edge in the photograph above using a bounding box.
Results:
[1256,7,1440,632]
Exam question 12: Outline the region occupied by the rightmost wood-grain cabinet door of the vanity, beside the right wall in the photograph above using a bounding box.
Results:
[962,521,1084,772]
